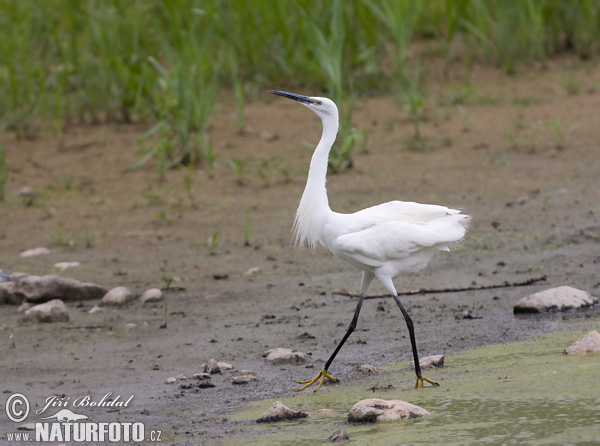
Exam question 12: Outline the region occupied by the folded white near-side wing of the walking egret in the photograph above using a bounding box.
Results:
[332,214,468,267]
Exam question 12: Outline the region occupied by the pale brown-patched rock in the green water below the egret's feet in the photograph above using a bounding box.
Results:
[348,398,431,423]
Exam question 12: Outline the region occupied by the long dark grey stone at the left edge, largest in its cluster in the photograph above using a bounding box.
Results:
[0,274,106,305]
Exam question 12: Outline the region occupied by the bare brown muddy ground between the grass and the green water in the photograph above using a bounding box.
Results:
[0,59,600,444]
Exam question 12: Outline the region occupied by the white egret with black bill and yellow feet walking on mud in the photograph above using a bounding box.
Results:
[269,90,470,392]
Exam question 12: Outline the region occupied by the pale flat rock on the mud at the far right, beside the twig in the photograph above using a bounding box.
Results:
[513,286,598,313]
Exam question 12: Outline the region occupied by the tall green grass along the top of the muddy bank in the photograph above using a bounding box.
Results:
[0,0,600,175]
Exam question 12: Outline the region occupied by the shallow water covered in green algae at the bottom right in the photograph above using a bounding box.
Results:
[235,332,600,445]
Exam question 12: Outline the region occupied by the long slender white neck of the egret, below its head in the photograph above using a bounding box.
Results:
[294,115,338,249]
